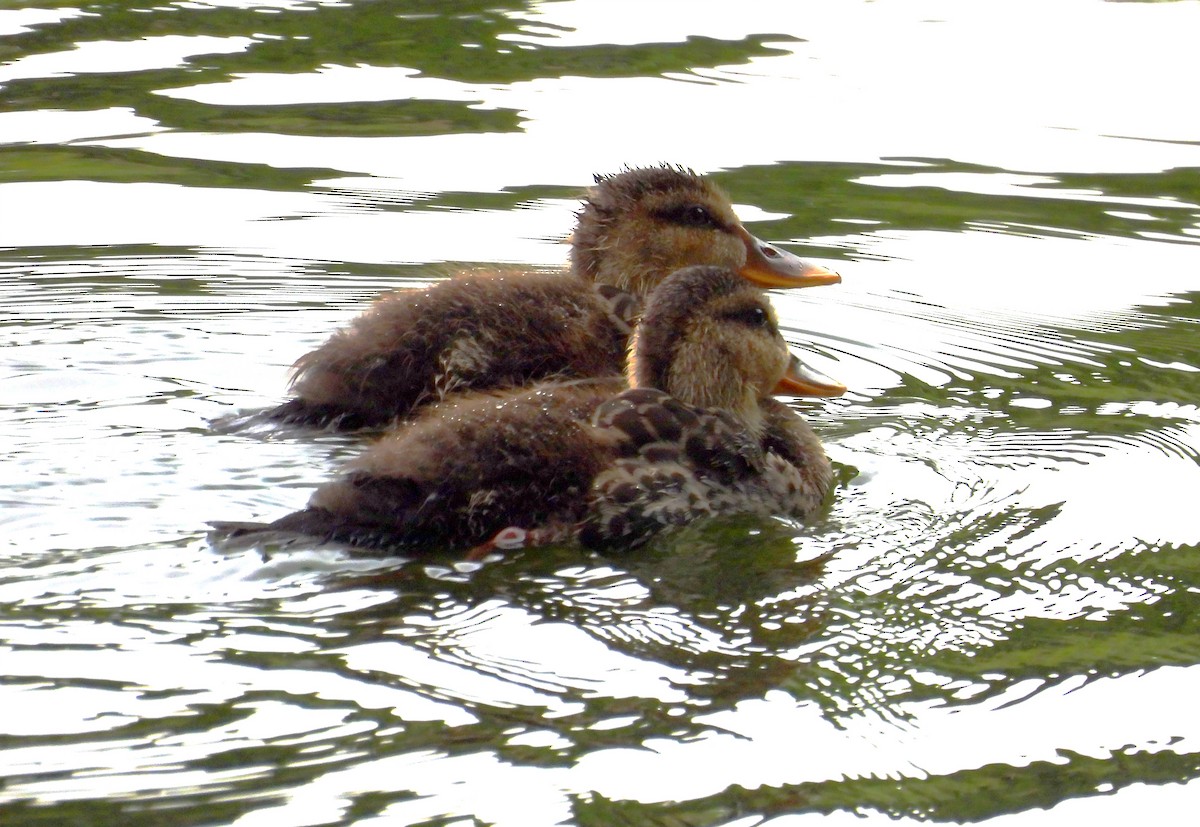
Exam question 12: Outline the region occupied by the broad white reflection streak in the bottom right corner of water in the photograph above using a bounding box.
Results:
[574,666,1200,802]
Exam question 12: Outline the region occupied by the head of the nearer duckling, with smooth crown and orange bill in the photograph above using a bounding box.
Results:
[626,266,846,431]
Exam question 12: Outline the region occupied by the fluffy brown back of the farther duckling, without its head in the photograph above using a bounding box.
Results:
[271,272,641,429]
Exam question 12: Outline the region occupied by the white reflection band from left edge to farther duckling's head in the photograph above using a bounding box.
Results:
[0,181,578,264]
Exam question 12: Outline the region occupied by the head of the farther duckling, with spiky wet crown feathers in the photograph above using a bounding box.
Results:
[571,166,841,295]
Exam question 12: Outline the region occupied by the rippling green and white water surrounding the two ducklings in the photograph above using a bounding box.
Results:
[0,0,1200,827]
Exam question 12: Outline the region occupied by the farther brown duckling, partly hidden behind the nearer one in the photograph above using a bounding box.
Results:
[265,166,841,430]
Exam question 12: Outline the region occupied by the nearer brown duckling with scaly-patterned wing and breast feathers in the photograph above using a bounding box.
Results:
[214,266,845,557]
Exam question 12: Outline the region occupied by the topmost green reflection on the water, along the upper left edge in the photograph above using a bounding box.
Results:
[7,0,797,83]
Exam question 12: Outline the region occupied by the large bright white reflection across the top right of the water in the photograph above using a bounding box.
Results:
[58,0,1200,191]
